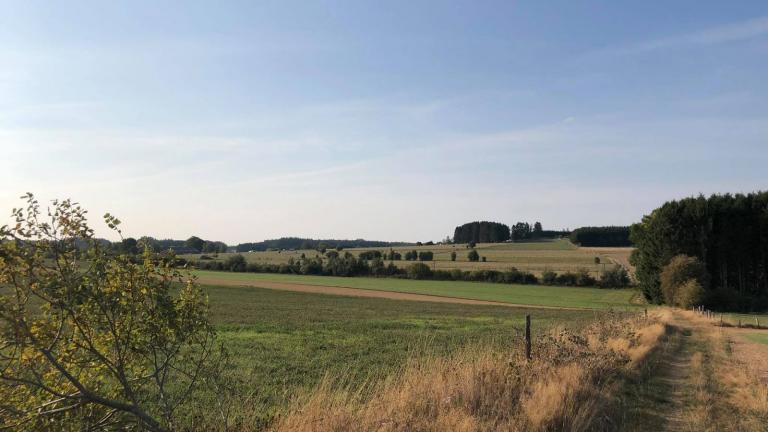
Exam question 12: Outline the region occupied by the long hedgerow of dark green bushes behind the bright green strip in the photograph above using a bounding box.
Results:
[195,250,630,288]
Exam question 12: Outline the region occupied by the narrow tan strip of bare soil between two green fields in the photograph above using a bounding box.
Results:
[198,276,584,310]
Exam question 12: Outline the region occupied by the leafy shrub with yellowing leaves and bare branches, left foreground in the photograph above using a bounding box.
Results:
[0,194,224,431]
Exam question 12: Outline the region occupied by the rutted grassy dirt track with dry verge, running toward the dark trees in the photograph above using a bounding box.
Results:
[622,311,768,431]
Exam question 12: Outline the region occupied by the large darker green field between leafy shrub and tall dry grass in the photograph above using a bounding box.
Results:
[205,278,594,425]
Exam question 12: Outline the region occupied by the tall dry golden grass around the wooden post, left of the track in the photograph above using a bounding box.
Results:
[274,316,664,432]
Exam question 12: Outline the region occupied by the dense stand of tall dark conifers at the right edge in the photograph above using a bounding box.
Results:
[632,192,768,311]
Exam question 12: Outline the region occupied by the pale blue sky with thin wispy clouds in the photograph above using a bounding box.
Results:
[0,0,768,244]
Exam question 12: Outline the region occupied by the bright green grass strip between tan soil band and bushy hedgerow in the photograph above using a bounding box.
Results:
[195,271,637,309]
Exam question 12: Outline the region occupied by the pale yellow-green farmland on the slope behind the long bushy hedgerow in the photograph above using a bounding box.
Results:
[182,239,632,276]
